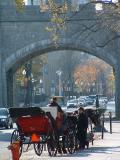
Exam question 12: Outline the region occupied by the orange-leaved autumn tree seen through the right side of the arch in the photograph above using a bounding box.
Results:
[74,58,110,94]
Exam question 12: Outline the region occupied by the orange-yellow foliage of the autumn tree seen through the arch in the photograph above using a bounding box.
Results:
[74,58,110,88]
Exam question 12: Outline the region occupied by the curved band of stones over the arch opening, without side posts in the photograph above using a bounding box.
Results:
[5,39,116,71]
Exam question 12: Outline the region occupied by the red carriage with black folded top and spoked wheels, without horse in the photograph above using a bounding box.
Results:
[9,107,75,156]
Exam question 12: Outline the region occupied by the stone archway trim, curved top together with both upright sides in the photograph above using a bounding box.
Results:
[5,39,119,115]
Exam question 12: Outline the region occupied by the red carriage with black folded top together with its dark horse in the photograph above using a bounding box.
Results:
[9,102,103,156]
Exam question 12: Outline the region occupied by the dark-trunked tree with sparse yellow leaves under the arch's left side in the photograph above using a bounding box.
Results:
[16,54,47,106]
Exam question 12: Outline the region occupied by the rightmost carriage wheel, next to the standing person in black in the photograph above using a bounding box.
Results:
[66,131,76,154]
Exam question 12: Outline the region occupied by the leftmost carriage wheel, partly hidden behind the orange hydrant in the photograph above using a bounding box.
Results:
[11,129,22,156]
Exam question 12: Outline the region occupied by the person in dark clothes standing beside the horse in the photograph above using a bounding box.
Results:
[77,107,88,149]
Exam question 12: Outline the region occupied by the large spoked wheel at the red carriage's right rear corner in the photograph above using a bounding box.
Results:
[47,131,57,156]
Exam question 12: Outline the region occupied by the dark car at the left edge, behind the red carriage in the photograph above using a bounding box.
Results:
[0,108,13,129]
